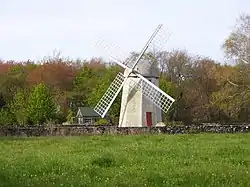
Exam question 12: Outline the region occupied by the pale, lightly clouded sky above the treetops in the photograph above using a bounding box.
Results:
[0,0,250,61]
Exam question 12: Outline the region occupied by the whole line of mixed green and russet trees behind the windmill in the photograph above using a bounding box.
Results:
[0,14,250,125]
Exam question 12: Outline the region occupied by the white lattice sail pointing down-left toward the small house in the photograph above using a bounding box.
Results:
[94,72,126,118]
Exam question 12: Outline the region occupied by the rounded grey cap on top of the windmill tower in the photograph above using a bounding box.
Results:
[127,59,159,78]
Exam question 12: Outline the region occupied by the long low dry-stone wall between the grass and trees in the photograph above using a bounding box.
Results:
[0,124,250,136]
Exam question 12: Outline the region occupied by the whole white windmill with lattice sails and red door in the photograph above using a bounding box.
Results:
[94,24,175,127]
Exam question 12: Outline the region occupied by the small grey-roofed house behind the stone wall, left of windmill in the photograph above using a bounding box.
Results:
[76,107,107,125]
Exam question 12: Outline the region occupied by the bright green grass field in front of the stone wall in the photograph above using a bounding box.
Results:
[0,134,250,187]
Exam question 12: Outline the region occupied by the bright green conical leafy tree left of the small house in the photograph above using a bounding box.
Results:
[27,83,57,124]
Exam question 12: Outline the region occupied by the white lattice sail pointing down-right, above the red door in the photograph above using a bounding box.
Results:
[129,74,175,113]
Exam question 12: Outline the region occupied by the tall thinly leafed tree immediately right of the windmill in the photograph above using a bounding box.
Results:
[155,50,193,123]
